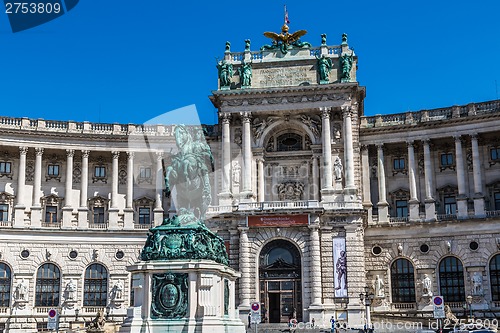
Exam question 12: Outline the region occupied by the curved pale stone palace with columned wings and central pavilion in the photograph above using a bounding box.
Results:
[0,24,500,332]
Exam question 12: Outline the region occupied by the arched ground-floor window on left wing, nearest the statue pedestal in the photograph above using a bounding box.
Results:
[83,264,108,306]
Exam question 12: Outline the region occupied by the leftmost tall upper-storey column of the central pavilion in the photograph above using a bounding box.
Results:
[219,114,231,206]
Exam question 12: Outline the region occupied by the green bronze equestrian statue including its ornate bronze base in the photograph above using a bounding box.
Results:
[141,125,228,265]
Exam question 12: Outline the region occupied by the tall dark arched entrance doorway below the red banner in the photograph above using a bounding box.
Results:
[259,239,302,323]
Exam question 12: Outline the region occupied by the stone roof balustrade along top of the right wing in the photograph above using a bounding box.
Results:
[361,100,500,128]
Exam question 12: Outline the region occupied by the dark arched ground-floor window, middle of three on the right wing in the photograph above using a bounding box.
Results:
[439,257,465,302]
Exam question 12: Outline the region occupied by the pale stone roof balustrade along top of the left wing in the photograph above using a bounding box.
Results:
[0,117,219,136]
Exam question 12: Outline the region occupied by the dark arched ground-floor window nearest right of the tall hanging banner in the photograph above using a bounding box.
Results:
[391,259,415,303]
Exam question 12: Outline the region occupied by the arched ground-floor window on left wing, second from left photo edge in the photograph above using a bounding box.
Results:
[35,263,61,306]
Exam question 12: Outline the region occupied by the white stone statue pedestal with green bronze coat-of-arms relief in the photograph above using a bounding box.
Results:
[119,259,245,333]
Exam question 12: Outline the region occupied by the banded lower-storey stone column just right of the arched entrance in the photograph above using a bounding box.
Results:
[309,223,322,306]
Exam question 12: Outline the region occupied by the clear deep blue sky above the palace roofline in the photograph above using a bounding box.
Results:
[0,0,500,123]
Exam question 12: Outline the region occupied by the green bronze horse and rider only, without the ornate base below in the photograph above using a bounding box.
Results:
[165,125,214,222]
